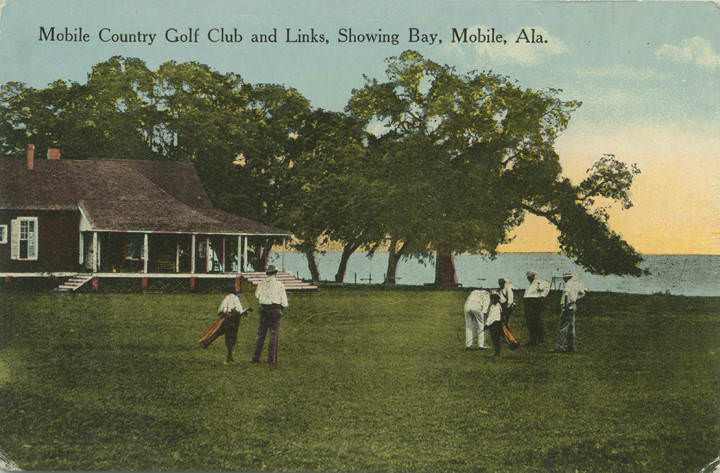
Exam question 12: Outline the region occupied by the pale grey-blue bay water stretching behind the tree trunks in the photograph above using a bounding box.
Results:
[269,252,720,296]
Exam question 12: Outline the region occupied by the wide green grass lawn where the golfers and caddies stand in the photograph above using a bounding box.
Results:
[0,288,720,472]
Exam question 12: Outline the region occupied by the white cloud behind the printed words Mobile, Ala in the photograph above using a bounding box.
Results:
[446,26,568,66]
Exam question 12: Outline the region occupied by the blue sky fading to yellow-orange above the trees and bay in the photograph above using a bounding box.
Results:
[0,0,720,254]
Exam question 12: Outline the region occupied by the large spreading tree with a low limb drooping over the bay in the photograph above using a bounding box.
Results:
[347,51,642,285]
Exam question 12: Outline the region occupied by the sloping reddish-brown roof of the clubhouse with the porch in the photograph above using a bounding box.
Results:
[0,158,288,235]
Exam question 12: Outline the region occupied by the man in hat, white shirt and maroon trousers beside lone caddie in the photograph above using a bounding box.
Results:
[252,265,288,369]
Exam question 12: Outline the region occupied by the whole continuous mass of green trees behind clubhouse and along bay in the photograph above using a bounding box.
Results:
[0,51,641,283]
